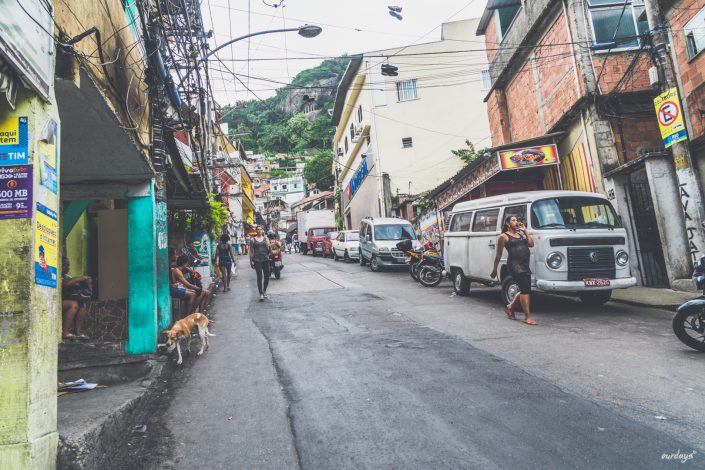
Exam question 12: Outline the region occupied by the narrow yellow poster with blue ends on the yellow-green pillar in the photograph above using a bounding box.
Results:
[34,202,59,287]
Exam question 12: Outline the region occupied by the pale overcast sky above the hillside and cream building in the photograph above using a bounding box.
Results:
[202,0,486,105]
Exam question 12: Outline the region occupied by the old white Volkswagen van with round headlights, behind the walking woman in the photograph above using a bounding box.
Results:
[443,191,636,305]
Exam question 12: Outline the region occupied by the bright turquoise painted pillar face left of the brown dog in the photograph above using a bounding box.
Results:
[125,183,158,354]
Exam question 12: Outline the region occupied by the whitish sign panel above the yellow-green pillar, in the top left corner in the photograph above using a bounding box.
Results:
[0,0,54,99]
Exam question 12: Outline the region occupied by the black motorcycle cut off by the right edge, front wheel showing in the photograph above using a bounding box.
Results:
[673,252,705,352]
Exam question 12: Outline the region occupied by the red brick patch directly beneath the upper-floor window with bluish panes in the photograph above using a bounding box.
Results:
[592,51,653,94]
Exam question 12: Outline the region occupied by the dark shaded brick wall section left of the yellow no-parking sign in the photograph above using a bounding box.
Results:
[610,114,663,164]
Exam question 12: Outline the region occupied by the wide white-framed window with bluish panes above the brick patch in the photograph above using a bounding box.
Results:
[588,0,649,50]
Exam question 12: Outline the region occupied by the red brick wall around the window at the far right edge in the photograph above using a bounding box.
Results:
[668,0,705,139]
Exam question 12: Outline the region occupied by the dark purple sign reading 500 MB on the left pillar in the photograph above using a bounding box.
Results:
[0,165,32,219]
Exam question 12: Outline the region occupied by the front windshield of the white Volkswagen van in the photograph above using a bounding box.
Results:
[531,196,622,229]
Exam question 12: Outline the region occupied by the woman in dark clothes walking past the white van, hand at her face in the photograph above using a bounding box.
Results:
[490,216,537,325]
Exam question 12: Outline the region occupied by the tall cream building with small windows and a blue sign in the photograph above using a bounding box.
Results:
[332,20,490,228]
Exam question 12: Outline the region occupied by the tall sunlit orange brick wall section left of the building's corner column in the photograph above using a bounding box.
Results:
[534,13,578,130]
